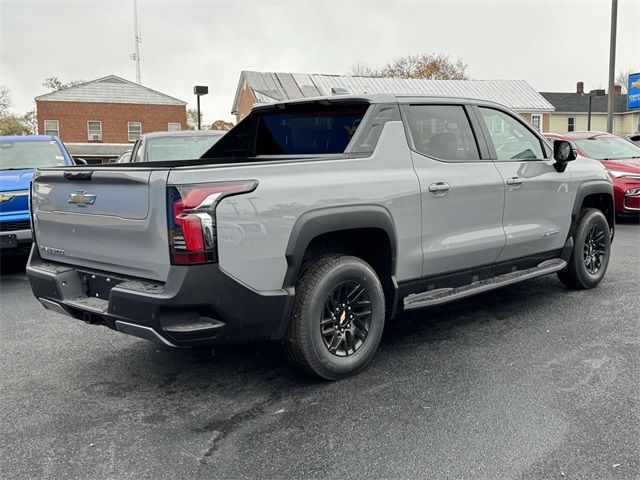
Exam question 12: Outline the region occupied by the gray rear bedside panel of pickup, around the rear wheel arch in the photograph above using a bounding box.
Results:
[168,121,422,291]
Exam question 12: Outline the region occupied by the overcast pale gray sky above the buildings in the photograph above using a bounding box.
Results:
[0,0,640,123]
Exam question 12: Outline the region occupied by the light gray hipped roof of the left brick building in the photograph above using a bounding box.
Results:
[35,75,187,105]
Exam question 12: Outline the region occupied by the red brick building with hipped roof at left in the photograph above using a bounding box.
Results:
[35,75,187,161]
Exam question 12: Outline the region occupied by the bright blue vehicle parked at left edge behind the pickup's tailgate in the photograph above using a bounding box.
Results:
[0,135,74,255]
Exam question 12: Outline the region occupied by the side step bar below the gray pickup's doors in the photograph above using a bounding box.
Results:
[404,258,567,310]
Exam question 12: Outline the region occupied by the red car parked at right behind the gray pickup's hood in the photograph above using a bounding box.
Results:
[544,132,640,215]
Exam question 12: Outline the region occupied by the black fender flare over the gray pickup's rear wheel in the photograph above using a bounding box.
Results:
[283,204,397,289]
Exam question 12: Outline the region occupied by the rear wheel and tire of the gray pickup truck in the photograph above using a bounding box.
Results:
[283,255,385,380]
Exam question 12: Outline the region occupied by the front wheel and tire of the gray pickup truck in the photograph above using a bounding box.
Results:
[558,208,611,289]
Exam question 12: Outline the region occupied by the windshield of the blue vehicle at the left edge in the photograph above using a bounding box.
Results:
[0,140,66,170]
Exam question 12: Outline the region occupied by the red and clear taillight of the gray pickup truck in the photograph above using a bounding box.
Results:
[167,180,258,265]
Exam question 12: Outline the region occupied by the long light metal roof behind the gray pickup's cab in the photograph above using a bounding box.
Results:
[232,71,554,112]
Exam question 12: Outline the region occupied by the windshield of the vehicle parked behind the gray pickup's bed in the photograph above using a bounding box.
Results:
[146,135,222,162]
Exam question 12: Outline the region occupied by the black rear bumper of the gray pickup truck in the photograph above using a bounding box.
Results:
[27,246,293,347]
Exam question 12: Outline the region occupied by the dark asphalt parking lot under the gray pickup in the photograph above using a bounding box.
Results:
[0,223,640,479]
